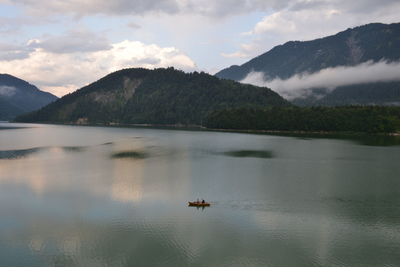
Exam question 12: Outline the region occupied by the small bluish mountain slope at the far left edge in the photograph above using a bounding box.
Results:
[0,74,57,120]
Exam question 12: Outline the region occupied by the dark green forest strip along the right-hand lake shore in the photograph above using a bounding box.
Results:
[206,106,400,133]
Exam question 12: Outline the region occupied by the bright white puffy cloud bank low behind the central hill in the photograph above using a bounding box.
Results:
[0,40,196,96]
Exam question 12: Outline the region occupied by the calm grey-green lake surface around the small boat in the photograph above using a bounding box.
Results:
[0,123,400,266]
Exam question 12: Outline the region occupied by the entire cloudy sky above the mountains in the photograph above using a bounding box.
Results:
[0,0,400,96]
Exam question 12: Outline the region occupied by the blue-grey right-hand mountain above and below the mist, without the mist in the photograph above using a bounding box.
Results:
[215,23,400,105]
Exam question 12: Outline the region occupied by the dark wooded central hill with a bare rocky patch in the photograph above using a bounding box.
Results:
[16,68,290,125]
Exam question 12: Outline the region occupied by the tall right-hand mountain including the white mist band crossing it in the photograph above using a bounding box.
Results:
[216,23,400,105]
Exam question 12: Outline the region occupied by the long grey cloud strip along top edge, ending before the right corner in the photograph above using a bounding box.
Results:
[12,0,293,17]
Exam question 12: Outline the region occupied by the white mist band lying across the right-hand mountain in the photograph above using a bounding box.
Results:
[241,61,400,100]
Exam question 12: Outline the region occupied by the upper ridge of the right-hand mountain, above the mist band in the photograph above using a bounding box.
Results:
[219,23,400,81]
